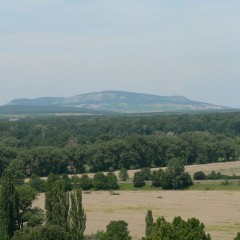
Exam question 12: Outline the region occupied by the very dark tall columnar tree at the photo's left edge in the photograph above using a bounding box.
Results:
[0,170,19,240]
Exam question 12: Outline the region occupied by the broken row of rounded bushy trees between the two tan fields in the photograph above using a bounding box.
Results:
[28,159,193,195]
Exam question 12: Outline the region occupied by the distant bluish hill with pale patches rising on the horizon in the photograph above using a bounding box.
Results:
[8,91,226,113]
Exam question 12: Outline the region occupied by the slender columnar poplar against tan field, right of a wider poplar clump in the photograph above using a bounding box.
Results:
[68,189,86,240]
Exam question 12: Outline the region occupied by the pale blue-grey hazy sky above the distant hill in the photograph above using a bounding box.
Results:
[0,0,240,106]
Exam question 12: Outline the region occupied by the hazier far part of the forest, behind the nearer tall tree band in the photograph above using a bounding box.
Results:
[0,112,240,148]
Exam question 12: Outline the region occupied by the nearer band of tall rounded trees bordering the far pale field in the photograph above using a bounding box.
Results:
[0,132,239,176]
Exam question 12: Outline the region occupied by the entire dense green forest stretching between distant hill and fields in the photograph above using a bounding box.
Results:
[0,112,240,176]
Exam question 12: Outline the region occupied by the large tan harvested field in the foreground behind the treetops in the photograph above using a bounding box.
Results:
[34,191,240,240]
